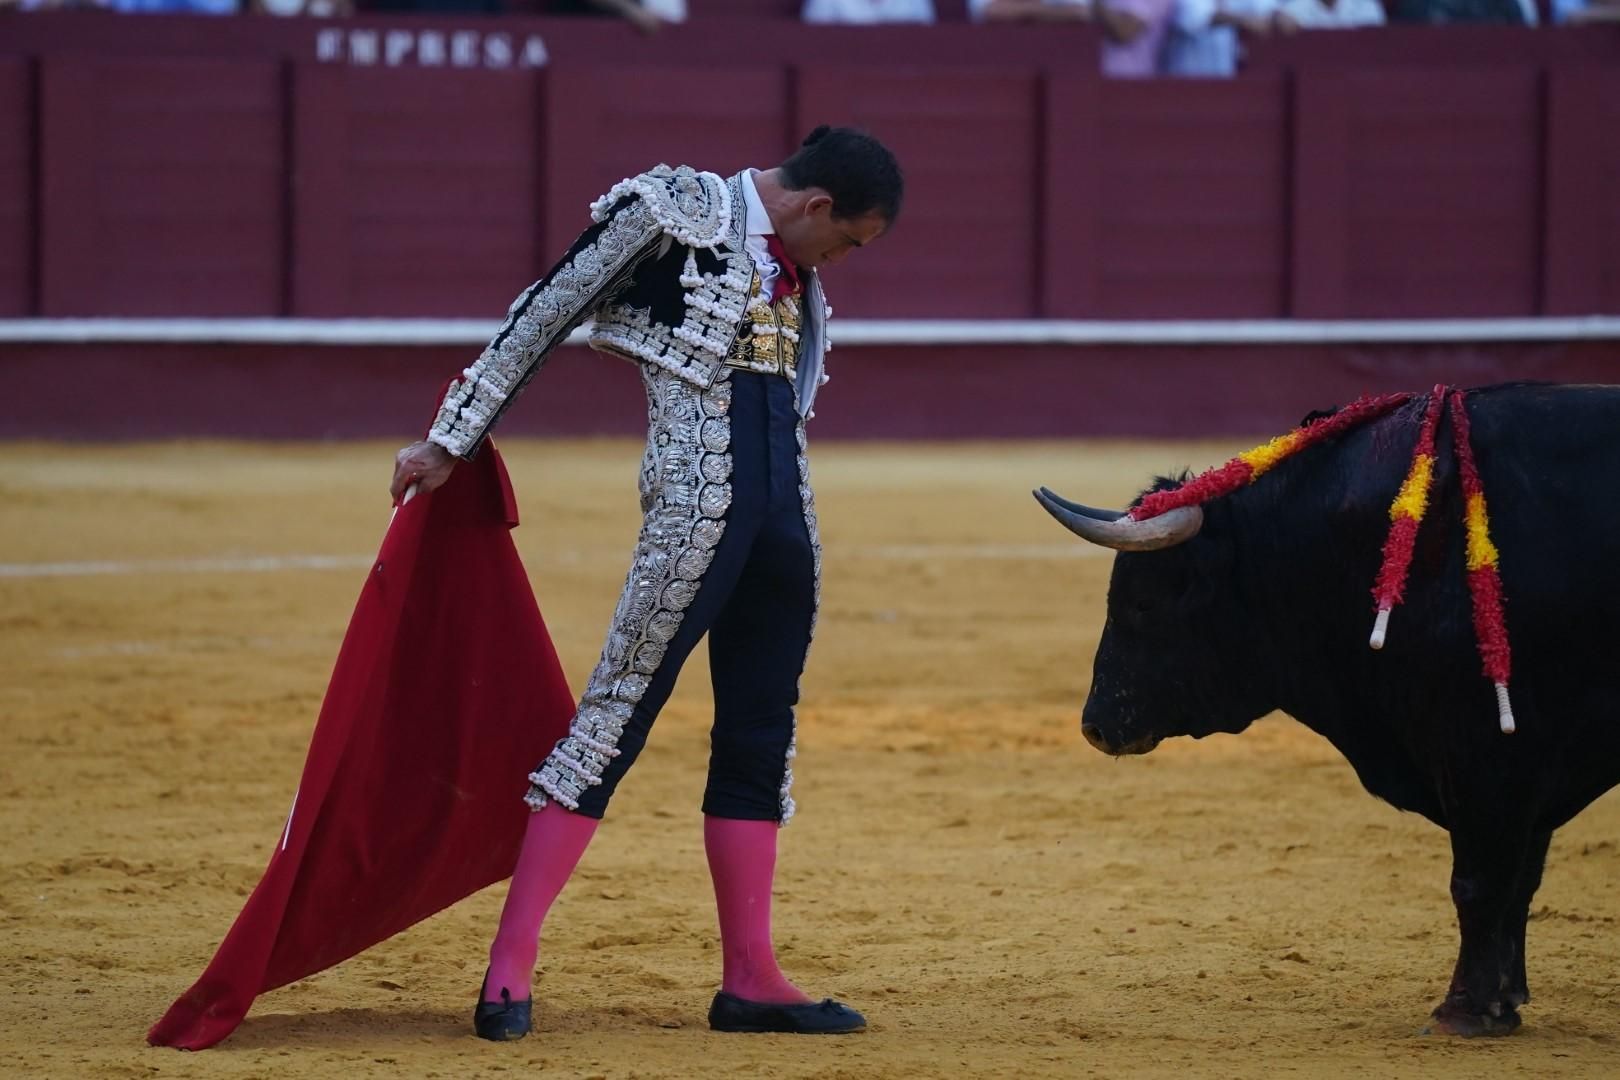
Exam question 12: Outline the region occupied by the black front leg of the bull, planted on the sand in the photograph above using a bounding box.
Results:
[1434,824,1533,1035]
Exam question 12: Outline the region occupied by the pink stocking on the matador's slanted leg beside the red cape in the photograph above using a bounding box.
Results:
[484,803,598,1002]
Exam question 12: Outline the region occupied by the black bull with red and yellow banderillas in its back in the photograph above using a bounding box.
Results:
[1042,385,1620,1035]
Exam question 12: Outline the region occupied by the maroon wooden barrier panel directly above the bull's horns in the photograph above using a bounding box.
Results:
[1042,74,1288,319]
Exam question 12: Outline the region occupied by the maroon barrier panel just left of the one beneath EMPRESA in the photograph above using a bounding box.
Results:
[39,55,287,316]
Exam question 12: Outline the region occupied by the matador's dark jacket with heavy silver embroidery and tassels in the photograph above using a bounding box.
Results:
[428,165,831,458]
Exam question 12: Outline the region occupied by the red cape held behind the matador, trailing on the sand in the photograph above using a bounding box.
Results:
[147,445,573,1049]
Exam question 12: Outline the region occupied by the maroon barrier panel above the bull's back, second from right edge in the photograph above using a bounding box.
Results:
[1293,66,1541,319]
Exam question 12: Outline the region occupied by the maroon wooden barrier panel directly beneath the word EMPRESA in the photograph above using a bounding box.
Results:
[292,65,546,317]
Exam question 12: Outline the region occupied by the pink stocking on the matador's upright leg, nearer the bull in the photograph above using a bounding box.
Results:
[703,816,810,1004]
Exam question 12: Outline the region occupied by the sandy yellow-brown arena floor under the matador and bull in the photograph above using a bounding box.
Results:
[0,432,1620,1080]
